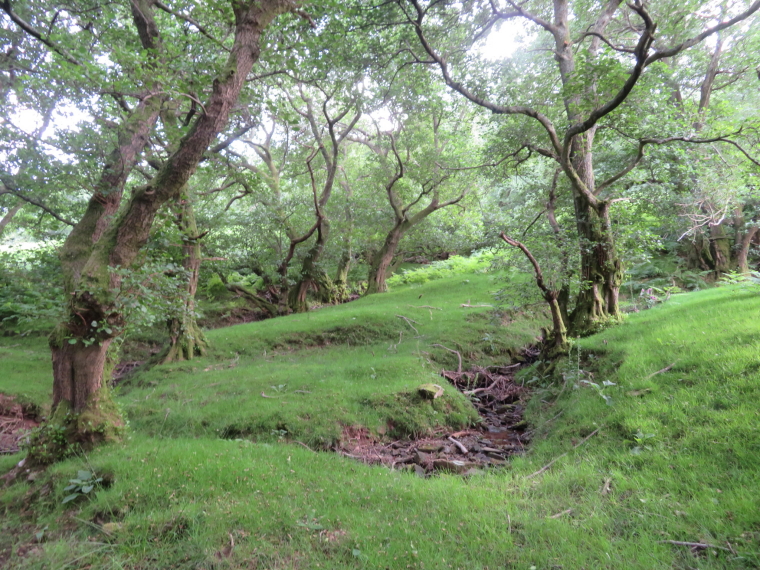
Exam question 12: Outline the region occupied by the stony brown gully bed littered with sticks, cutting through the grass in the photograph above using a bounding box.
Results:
[336,364,530,476]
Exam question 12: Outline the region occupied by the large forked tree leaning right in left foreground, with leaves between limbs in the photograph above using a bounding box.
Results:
[2,0,308,454]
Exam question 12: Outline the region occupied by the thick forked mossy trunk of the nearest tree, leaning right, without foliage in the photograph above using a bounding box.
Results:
[44,0,296,452]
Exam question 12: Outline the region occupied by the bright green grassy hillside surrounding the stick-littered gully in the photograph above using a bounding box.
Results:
[0,274,760,570]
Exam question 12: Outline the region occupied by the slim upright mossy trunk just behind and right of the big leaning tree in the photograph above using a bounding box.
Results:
[162,201,208,363]
